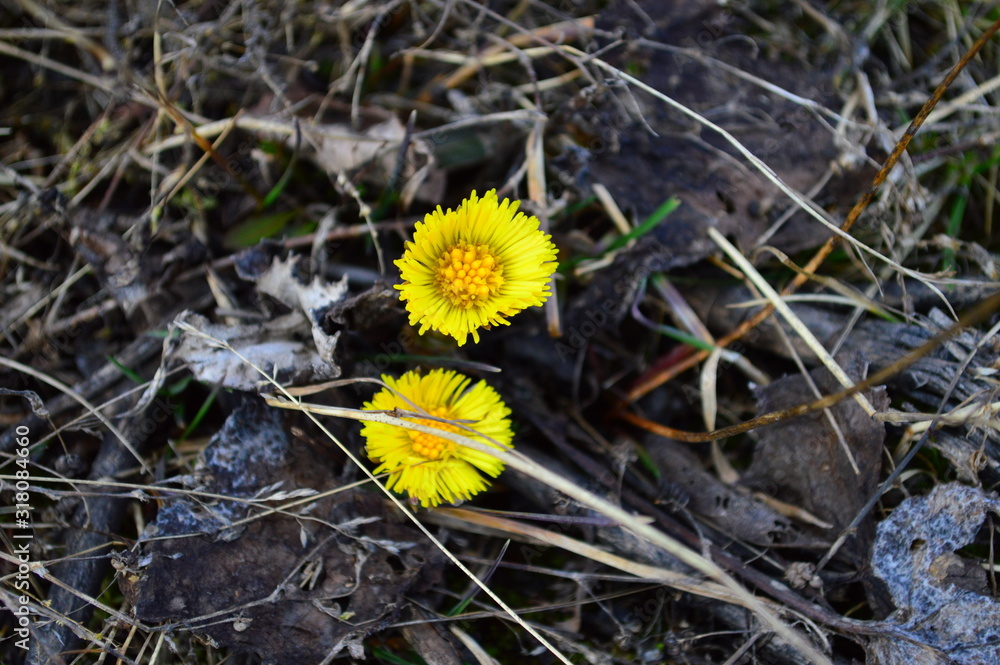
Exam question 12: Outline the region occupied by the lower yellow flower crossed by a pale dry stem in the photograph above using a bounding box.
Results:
[361,369,514,507]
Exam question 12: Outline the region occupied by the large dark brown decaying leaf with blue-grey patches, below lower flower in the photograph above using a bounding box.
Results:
[127,402,433,665]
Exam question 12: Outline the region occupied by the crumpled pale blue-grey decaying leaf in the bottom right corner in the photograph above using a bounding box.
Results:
[869,483,1000,665]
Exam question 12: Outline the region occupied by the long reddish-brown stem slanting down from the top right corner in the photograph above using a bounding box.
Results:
[628,19,1000,402]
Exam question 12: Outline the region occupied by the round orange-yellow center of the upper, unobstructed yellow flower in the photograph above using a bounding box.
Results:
[437,242,503,309]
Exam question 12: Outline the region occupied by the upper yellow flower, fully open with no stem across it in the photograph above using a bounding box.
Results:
[395,189,556,346]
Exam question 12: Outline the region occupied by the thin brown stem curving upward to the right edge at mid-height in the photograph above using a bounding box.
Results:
[618,292,1000,443]
